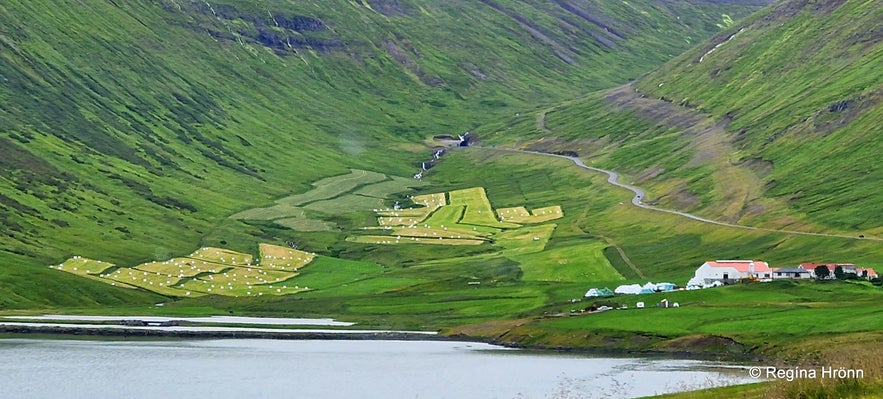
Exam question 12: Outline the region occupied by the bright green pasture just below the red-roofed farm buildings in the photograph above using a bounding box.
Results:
[540,281,883,337]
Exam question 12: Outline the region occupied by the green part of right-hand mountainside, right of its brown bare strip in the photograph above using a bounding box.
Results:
[636,1,883,231]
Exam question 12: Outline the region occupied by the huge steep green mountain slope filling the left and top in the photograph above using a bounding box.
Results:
[0,0,762,308]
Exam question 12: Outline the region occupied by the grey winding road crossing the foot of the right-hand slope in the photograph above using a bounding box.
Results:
[486,149,883,241]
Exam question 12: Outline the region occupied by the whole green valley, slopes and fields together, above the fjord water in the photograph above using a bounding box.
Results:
[0,0,883,397]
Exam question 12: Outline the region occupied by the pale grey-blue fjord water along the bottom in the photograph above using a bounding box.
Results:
[0,339,748,399]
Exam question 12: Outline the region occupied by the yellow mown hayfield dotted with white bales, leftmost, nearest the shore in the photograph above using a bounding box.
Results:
[50,243,315,297]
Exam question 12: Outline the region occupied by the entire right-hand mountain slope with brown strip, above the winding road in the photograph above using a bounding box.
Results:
[489,0,883,235]
